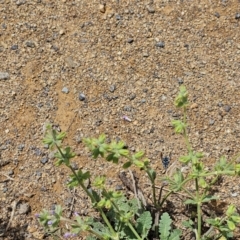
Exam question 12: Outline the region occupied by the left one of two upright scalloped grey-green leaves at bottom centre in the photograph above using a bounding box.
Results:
[137,212,152,239]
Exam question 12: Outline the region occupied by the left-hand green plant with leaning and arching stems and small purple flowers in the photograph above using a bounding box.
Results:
[38,125,180,239]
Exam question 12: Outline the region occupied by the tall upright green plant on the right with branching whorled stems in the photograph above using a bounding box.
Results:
[169,86,240,240]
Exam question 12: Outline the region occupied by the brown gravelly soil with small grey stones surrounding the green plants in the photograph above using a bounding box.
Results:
[0,0,240,240]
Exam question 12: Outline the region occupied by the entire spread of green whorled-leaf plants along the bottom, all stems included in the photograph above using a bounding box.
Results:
[39,86,240,240]
